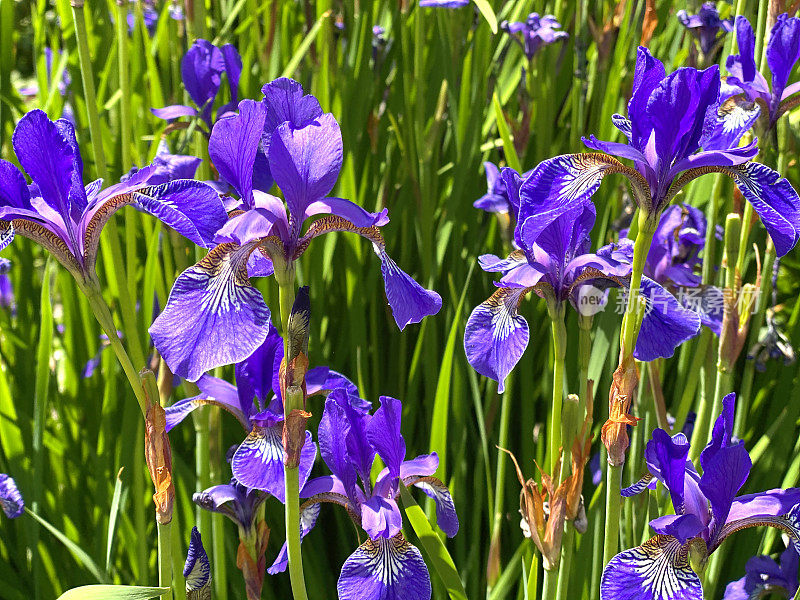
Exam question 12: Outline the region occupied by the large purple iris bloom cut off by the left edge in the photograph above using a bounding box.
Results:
[0,110,227,281]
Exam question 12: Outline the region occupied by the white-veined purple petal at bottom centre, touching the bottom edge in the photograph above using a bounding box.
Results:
[336,534,431,600]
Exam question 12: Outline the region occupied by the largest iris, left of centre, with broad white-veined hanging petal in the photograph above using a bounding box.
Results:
[150,78,442,381]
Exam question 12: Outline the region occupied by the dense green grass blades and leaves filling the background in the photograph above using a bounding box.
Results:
[0,0,800,600]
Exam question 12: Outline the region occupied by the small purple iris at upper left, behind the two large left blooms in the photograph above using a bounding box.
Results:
[150,39,242,131]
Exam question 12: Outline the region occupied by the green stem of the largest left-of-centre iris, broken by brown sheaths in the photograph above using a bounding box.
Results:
[275,263,308,600]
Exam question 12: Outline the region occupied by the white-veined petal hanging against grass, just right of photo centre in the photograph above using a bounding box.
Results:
[464,288,530,393]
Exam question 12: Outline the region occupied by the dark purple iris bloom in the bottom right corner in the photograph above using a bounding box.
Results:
[722,544,798,600]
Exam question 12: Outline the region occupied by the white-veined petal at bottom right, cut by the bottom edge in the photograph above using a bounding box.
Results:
[600,535,703,600]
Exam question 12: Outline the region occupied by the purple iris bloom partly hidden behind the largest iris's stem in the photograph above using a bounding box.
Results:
[165,324,356,502]
